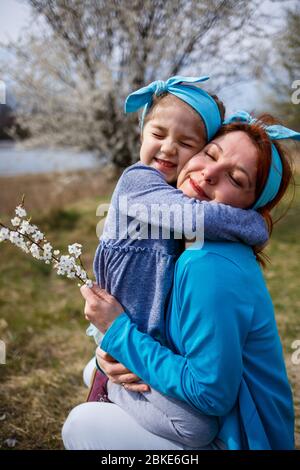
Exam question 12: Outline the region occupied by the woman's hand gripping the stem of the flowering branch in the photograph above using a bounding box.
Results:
[80,284,124,333]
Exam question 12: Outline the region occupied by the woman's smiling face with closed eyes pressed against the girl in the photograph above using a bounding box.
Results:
[177,131,258,209]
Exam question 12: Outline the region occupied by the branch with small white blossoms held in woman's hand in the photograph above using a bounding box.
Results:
[0,196,93,287]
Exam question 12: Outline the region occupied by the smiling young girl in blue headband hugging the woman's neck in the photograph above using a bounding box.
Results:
[84,77,268,448]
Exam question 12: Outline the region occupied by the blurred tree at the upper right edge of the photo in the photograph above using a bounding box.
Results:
[269,3,300,131]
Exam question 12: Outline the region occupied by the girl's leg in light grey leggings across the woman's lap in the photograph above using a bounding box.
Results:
[108,381,219,449]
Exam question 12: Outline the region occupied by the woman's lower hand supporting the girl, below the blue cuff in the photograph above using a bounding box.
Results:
[96,347,150,392]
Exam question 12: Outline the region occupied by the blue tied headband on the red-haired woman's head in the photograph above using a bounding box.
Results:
[223,111,300,209]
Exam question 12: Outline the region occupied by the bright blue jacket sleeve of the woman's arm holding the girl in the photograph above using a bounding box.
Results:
[101,254,252,416]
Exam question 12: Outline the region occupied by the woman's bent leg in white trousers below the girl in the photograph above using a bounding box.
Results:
[62,402,188,450]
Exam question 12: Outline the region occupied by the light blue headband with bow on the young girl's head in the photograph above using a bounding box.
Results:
[125,75,221,141]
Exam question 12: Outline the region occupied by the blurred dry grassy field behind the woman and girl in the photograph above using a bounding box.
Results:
[0,166,300,449]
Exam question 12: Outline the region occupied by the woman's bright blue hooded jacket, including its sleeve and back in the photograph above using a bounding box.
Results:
[101,242,294,450]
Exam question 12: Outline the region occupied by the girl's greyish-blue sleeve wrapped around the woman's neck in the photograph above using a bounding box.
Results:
[117,163,269,245]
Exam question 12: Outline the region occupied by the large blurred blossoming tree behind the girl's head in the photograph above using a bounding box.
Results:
[0,0,275,167]
